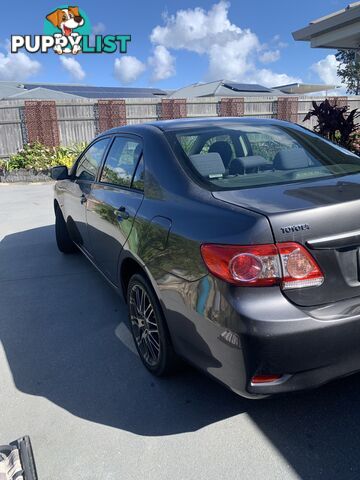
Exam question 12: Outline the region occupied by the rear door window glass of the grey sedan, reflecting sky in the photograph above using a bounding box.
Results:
[100,137,142,187]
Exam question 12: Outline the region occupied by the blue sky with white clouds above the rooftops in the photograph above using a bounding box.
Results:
[0,0,349,89]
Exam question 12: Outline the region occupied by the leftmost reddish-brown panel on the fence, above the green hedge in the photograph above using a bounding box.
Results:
[23,100,60,147]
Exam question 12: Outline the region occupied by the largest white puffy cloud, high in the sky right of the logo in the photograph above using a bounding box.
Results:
[150,0,299,86]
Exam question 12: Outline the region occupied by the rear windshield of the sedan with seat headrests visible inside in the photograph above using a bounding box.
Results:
[166,123,360,190]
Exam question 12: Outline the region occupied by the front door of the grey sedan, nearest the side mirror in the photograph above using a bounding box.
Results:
[64,137,110,251]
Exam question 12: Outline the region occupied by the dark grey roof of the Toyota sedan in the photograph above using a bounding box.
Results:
[96,117,296,136]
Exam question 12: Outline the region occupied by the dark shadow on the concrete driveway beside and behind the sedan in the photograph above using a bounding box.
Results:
[0,226,360,479]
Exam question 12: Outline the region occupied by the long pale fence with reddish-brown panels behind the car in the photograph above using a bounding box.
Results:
[0,96,360,159]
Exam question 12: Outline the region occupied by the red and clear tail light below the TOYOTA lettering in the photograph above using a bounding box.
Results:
[201,242,324,289]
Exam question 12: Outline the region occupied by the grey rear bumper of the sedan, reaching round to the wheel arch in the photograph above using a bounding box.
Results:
[160,276,360,398]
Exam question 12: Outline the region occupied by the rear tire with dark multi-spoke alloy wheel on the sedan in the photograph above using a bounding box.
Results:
[127,274,178,377]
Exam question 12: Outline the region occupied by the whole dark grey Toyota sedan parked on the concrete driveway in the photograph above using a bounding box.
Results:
[52,118,360,398]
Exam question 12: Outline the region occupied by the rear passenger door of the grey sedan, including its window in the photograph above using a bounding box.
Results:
[86,135,144,283]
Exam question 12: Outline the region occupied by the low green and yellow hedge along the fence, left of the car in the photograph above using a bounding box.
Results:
[0,142,86,172]
